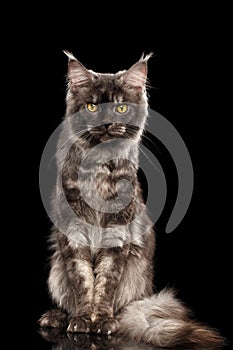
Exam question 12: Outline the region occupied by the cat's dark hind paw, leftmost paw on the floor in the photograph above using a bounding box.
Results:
[38,309,68,328]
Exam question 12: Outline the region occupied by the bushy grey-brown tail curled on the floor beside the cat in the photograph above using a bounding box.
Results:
[119,289,224,348]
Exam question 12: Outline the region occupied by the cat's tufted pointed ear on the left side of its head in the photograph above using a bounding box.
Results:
[64,51,93,92]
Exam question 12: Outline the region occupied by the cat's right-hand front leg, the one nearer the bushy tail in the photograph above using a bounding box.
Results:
[91,245,129,334]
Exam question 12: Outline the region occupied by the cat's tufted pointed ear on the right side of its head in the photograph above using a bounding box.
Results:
[122,53,153,92]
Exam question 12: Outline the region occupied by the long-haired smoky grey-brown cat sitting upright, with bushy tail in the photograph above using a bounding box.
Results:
[38,51,224,347]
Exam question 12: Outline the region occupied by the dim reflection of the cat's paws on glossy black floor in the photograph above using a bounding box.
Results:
[39,328,227,350]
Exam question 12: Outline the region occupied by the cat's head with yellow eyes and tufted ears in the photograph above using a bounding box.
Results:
[65,51,152,148]
